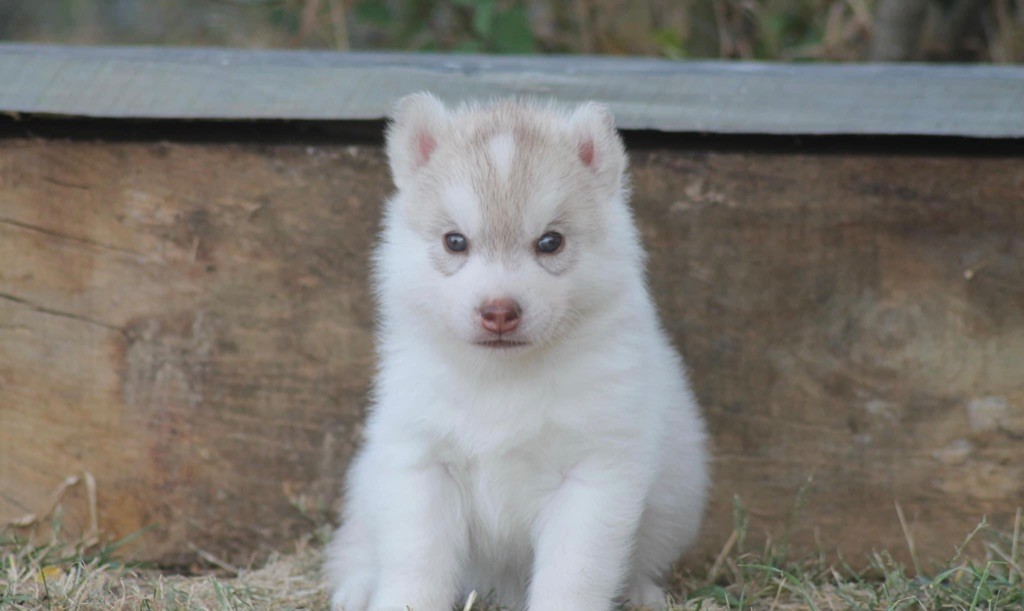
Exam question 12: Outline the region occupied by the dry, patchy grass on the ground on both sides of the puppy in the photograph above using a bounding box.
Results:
[0,505,1024,611]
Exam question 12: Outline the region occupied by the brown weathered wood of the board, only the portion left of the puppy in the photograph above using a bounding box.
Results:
[0,141,387,560]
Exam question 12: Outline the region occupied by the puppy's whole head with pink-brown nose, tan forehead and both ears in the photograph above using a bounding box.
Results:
[383,94,626,352]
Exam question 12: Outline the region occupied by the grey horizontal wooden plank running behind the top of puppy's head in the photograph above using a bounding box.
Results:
[0,45,1024,138]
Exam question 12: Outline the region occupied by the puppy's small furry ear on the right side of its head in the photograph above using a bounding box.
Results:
[569,102,627,198]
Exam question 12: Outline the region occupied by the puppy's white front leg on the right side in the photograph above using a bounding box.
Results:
[528,469,642,611]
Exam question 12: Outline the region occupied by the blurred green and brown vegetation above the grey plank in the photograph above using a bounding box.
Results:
[0,0,1024,63]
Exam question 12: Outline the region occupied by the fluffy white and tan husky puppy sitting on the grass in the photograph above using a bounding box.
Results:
[326,94,708,611]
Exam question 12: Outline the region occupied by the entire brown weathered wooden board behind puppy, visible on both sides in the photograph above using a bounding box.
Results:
[0,139,1024,563]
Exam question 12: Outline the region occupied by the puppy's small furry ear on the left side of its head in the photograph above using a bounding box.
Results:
[387,92,449,189]
